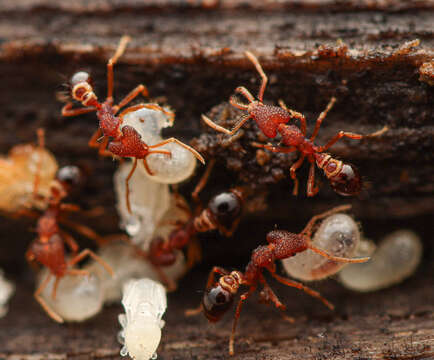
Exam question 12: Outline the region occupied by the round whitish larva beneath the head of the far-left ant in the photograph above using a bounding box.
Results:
[38,268,103,322]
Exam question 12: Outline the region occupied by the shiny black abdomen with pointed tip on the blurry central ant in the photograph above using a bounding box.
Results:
[208,190,243,236]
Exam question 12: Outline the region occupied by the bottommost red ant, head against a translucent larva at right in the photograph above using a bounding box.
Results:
[195,205,369,355]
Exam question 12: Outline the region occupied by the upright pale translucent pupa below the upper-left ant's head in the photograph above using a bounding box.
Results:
[114,162,170,247]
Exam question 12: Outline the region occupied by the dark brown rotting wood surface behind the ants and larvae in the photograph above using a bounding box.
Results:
[0,0,434,359]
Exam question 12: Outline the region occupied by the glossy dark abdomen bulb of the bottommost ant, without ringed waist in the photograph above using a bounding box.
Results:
[202,285,234,322]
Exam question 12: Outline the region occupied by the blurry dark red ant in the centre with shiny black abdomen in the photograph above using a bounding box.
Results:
[142,160,244,288]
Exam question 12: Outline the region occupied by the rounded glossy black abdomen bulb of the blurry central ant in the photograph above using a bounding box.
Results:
[208,192,242,232]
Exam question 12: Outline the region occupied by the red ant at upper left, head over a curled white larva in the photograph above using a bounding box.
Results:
[62,36,205,213]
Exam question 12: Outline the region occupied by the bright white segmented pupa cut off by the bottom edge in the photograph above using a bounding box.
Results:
[118,279,167,360]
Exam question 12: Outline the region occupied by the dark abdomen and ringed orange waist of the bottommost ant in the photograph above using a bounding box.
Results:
[202,271,242,322]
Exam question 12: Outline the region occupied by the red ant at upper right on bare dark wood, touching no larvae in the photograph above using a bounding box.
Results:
[202,51,388,196]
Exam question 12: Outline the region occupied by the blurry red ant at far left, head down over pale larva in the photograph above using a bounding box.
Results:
[26,167,113,323]
